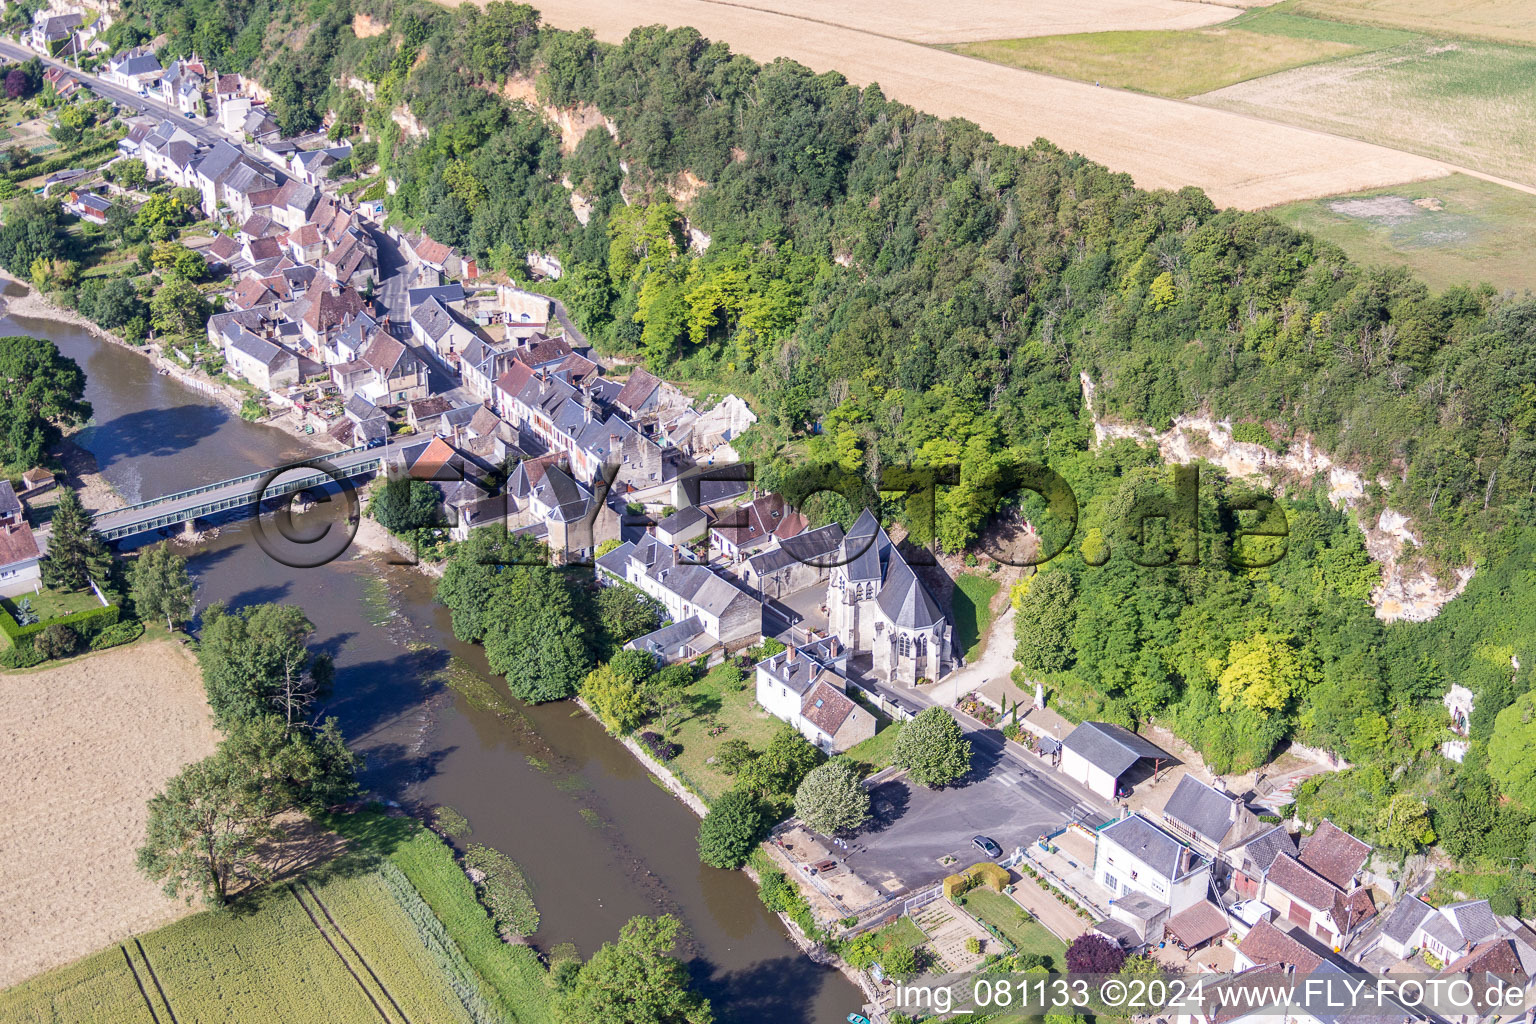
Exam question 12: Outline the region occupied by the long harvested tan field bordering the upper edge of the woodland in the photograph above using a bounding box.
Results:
[539,0,1450,209]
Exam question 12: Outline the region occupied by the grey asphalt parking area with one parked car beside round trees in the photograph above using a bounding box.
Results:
[845,734,1098,892]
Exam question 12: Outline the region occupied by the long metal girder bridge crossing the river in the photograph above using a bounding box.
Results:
[91,447,387,540]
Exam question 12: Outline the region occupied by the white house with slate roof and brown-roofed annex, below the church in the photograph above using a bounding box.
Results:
[754,637,876,754]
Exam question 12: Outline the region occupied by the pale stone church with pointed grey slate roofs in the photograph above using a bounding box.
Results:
[826,508,951,686]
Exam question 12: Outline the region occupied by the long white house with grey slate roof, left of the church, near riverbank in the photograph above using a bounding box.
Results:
[599,534,762,648]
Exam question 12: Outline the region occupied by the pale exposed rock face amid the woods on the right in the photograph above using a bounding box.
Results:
[1081,373,1476,622]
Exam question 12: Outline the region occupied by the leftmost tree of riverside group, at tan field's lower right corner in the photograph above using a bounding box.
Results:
[138,751,278,906]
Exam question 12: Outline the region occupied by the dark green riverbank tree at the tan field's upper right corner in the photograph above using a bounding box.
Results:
[198,605,332,728]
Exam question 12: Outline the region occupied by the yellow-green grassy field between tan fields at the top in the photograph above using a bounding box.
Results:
[954,8,1412,98]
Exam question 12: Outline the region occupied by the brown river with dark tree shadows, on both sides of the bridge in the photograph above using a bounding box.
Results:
[18,316,863,1024]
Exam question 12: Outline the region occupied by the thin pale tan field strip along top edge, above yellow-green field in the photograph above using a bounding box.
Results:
[660,0,1241,43]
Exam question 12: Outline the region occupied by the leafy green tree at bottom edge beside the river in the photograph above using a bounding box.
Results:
[553,913,714,1024]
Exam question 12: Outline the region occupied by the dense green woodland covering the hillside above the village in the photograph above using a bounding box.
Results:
[112,0,1536,906]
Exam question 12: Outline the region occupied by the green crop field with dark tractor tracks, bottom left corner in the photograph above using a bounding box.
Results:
[0,869,470,1024]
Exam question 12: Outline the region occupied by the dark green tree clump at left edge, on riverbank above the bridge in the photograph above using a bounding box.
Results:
[0,334,91,466]
